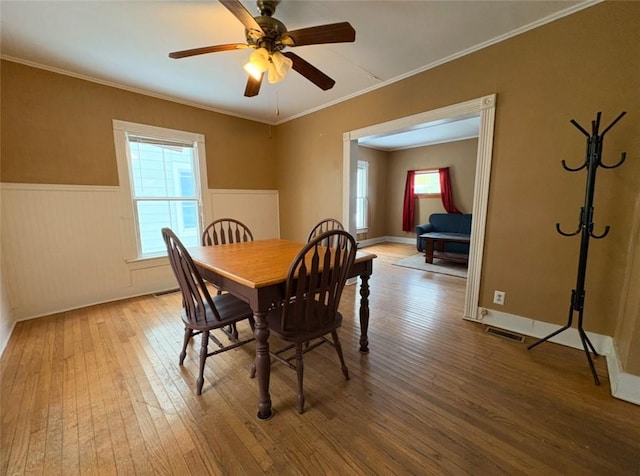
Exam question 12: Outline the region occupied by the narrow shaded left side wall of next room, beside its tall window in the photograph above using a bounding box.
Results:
[358,147,389,240]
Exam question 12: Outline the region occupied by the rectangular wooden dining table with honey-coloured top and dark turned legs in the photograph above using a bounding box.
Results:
[189,239,376,420]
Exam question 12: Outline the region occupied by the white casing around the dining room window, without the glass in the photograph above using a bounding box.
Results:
[113,119,212,262]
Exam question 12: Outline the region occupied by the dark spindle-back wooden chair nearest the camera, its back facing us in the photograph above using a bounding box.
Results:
[251,230,356,413]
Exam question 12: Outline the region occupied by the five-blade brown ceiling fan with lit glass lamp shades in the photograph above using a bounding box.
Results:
[169,0,356,97]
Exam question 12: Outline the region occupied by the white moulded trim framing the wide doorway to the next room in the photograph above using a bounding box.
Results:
[342,94,496,320]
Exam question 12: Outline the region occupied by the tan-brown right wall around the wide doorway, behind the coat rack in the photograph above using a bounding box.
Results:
[277,2,640,372]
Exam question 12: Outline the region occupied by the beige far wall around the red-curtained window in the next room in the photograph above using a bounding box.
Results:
[387,139,478,238]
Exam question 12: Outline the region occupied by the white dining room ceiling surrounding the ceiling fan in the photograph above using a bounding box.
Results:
[0,0,594,130]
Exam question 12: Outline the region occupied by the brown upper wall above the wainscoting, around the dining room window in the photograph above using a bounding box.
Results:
[0,61,276,189]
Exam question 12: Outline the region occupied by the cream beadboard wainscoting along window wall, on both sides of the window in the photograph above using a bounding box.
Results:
[0,183,280,326]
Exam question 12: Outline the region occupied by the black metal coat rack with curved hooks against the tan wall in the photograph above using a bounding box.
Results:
[528,112,627,385]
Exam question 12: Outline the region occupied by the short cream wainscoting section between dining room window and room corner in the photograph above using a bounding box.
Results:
[209,189,280,240]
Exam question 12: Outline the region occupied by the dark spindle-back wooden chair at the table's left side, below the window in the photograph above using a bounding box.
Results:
[162,228,254,395]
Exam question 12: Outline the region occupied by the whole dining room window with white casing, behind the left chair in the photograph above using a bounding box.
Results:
[114,121,206,259]
